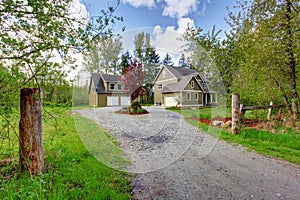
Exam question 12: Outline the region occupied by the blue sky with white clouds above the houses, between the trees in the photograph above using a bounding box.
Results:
[74,0,235,63]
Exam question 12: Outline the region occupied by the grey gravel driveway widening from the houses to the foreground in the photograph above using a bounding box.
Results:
[77,107,300,200]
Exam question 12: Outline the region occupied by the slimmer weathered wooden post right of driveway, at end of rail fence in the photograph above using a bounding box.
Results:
[231,93,241,134]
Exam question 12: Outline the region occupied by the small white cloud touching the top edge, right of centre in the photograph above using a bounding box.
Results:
[162,0,198,18]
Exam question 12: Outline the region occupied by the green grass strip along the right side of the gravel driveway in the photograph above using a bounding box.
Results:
[169,108,300,164]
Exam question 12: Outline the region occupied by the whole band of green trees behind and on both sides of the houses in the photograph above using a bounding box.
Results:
[0,0,300,119]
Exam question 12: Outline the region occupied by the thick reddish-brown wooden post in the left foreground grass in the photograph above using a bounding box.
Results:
[19,88,44,176]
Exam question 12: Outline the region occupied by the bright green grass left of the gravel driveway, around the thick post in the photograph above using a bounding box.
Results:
[0,108,132,199]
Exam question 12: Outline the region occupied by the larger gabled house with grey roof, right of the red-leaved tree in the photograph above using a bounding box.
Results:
[153,65,216,107]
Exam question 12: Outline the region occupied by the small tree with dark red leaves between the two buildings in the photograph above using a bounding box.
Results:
[121,60,144,102]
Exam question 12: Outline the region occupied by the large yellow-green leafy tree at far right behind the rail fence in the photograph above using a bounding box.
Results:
[229,0,300,119]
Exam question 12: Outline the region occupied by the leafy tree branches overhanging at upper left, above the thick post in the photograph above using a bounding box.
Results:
[0,0,122,172]
